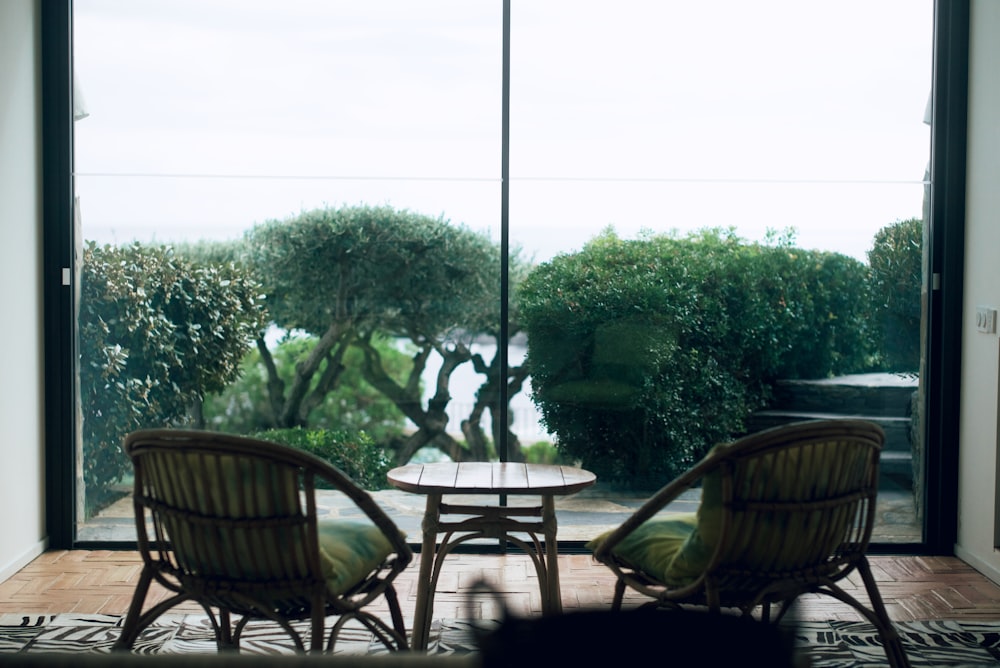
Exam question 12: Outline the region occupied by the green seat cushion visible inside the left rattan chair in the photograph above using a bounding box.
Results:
[318,520,393,595]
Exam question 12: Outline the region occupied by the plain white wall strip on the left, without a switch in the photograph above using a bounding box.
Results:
[0,0,45,580]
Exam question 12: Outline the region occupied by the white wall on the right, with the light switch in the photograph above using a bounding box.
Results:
[956,0,1000,582]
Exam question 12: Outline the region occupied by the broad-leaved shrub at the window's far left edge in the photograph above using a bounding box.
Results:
[79,242,263,508]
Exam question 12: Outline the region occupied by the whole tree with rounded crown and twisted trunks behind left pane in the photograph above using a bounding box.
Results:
[246,206,500,462]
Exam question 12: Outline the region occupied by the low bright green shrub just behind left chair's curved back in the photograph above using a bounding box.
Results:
[252,427,392,490]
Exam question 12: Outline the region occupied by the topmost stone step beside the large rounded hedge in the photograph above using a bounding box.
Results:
[768,373,917,417]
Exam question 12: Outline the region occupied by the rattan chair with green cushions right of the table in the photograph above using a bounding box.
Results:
[588,419,909,667]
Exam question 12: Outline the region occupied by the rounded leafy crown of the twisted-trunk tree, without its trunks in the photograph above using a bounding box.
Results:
[247,206,500,339]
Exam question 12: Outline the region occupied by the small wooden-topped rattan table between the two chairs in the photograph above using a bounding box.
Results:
[388,462,597,650]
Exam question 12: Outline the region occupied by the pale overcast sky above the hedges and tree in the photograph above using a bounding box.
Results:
[74,0,933,259]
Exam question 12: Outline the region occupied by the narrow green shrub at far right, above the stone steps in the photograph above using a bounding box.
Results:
[868,218,923,371]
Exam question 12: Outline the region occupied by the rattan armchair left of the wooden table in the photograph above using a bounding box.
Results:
[115,430,412,652]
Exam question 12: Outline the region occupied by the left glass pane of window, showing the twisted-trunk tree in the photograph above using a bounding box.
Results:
[74,0,502,540]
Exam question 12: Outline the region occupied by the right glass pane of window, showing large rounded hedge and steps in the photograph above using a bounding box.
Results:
[510,0,932,542]
